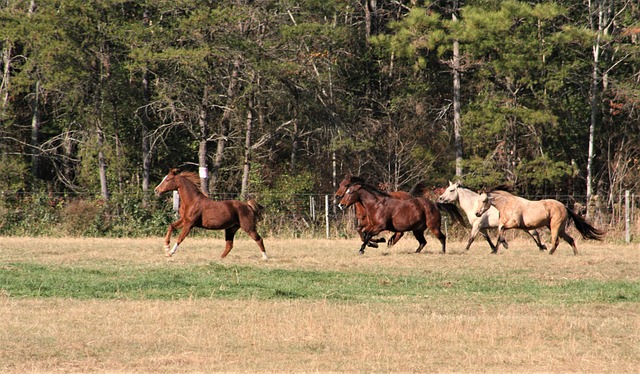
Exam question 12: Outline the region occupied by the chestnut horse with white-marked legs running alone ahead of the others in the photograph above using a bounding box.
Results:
[154,169,267,260]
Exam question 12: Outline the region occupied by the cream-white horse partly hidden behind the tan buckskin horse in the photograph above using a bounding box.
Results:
[437,182,547,253]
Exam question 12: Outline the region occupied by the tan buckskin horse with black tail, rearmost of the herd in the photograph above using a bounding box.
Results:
[476,186,605,255]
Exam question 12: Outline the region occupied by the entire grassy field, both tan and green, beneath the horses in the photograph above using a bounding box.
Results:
[0,235,640,373]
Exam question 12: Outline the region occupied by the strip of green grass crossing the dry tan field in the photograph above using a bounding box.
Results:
[0,263,640,304]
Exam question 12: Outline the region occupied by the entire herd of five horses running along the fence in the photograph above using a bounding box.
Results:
[154,169,605,260]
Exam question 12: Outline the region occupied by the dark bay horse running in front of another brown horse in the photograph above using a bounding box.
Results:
[339,183,464,254]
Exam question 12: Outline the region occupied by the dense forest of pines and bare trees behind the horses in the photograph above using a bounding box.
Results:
[0,0,640,236]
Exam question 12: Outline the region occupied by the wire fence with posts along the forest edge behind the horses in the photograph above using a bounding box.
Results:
[0,191,640,243]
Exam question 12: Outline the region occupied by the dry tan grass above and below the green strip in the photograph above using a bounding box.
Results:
[0,238,640,373]
